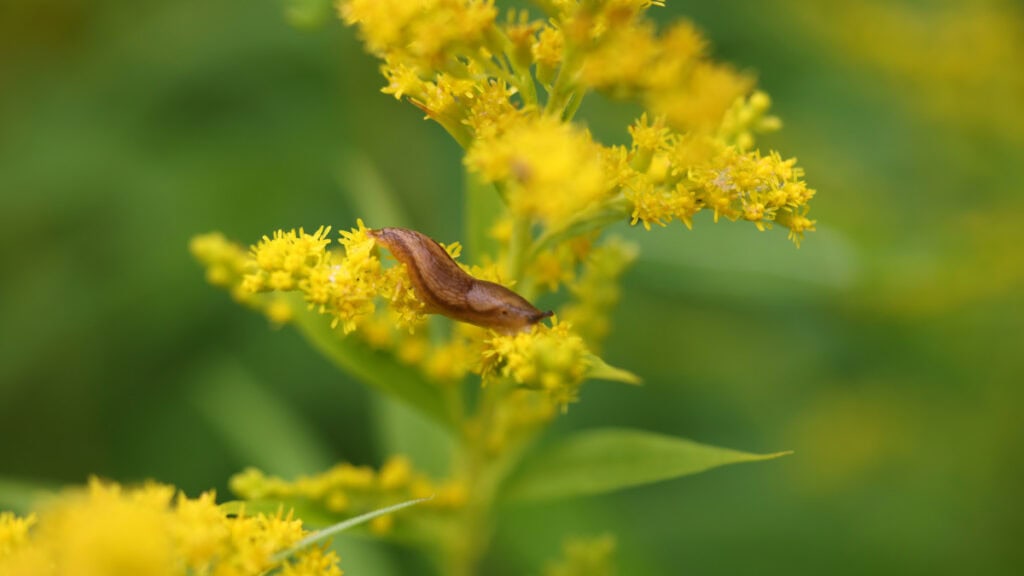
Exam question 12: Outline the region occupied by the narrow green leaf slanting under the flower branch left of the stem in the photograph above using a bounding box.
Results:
[292,295,456,428]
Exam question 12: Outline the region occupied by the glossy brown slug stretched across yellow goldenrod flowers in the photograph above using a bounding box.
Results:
[367,228,551,332]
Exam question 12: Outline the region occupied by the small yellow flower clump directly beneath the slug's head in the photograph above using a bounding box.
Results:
[482,319,592,410]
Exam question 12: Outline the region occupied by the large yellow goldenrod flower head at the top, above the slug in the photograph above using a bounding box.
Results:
[339,0,814,243]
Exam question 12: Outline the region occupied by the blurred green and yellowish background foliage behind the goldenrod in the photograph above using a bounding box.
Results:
[0,0,1024,576]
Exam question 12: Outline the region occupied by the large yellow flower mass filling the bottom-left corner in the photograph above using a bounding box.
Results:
[0,480,341,576]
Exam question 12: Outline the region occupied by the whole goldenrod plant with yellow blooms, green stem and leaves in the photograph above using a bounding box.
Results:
[0,0,814,576]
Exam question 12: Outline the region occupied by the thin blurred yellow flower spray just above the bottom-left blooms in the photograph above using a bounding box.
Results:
[230,456,466,534]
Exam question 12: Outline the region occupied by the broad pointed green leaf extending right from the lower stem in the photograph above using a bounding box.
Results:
[504,428,791,501]
